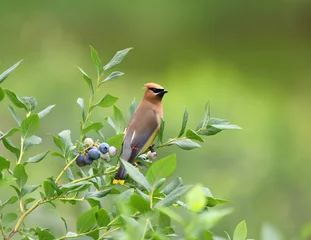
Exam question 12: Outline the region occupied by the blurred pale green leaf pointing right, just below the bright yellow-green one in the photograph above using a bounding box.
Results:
[199,209,232,229]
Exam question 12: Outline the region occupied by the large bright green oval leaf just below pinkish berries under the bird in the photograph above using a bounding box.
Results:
[146,154,176,186]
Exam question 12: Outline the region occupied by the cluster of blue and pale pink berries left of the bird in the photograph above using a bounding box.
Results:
[75,138,117,167]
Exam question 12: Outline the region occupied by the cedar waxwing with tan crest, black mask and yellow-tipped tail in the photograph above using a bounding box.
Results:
[113,83,167,184]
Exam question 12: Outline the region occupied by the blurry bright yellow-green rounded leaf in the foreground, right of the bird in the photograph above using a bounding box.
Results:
[186,184,207,213]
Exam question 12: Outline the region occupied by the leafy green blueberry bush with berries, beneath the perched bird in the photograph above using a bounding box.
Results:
[0,47,247,240]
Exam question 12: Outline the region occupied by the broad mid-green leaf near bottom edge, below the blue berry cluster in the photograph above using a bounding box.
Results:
[76,207,98,233]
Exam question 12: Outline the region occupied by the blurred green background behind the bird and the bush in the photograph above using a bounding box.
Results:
[0,0,311,239]
